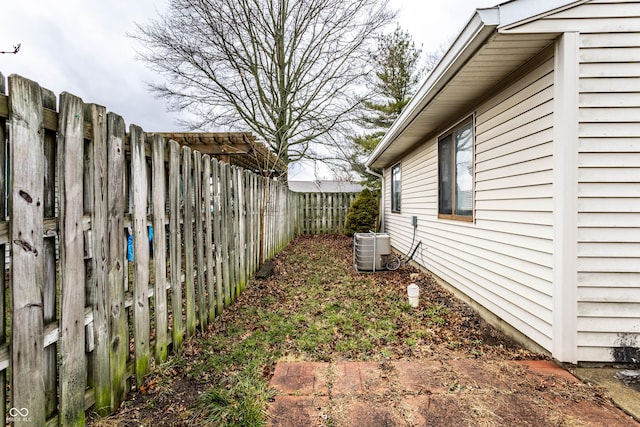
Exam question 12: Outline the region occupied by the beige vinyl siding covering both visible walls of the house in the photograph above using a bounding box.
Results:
[386,0,640,361]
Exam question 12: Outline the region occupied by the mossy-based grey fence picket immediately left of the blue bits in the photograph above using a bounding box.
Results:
[107,113,129,410]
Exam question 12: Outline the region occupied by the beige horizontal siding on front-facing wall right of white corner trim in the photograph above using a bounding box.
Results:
[507,0,640,361]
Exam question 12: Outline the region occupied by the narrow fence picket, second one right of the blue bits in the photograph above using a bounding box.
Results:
[169,141,183,351]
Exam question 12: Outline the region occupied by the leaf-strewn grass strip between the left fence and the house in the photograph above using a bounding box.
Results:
[105,236,532,426]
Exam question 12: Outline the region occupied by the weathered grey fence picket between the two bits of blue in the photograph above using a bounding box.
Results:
[129,125,150,386]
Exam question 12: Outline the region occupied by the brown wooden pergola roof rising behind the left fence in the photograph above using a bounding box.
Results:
[157,132,287,177]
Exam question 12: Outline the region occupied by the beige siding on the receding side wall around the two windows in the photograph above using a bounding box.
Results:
[386,49,553,350]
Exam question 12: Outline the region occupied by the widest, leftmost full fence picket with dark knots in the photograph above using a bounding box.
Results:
[9,75,45,425]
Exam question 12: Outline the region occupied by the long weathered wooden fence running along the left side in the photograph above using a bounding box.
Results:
[0,74,300,426]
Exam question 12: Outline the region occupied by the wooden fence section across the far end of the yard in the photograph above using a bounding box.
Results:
[298,193,358,234]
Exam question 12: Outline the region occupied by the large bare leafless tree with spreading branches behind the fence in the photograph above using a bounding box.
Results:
[133,0,394,163]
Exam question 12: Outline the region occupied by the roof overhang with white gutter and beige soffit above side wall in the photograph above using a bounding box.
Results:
[366,0,576,168]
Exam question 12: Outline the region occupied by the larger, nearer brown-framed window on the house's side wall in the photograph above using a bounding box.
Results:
[438,118,474,221]
